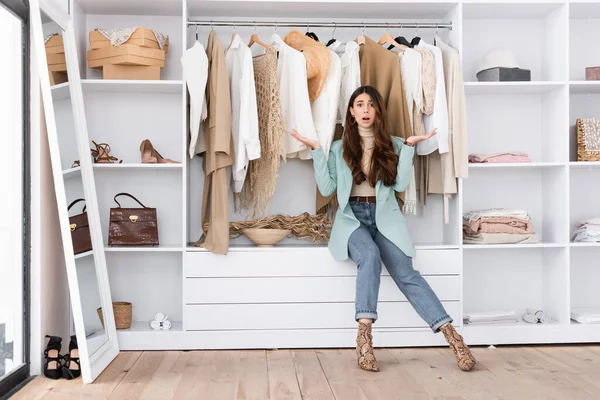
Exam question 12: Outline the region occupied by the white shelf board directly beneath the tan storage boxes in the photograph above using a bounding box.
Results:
[81,79,183,94]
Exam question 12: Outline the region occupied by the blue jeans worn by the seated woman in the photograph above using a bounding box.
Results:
[348,201,452,333]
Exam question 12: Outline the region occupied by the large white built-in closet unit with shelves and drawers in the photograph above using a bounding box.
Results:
[68,0,600,350]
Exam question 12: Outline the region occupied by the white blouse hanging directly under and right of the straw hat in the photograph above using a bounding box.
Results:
[312,50,342,158]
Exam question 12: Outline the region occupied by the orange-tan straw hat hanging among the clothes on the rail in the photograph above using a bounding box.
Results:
[283,30,331,101]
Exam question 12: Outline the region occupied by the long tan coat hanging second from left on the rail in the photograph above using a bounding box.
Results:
[199,30,233,254]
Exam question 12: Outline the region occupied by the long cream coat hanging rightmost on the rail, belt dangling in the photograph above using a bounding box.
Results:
[428,38,469,223]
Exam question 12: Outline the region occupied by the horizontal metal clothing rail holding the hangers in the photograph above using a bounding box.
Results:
[187,19,452,32]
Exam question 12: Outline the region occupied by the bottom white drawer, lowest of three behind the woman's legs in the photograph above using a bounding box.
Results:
[185,302,460,331]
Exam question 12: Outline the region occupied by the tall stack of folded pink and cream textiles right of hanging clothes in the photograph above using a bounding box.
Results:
[463,208,537,244]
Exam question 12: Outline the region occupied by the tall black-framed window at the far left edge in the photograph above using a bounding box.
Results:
[0,0,30,397]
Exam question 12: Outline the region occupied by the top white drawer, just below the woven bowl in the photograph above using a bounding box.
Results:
[184,247,462,278]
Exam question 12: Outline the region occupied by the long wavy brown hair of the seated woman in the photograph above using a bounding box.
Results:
[342,86,398,187]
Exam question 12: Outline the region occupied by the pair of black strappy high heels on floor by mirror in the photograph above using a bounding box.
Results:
[44,335,81,380]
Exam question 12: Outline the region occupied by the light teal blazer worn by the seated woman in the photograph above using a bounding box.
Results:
[311,136,415,261]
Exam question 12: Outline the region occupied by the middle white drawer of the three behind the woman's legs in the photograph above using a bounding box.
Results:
[184,275,461,304]
